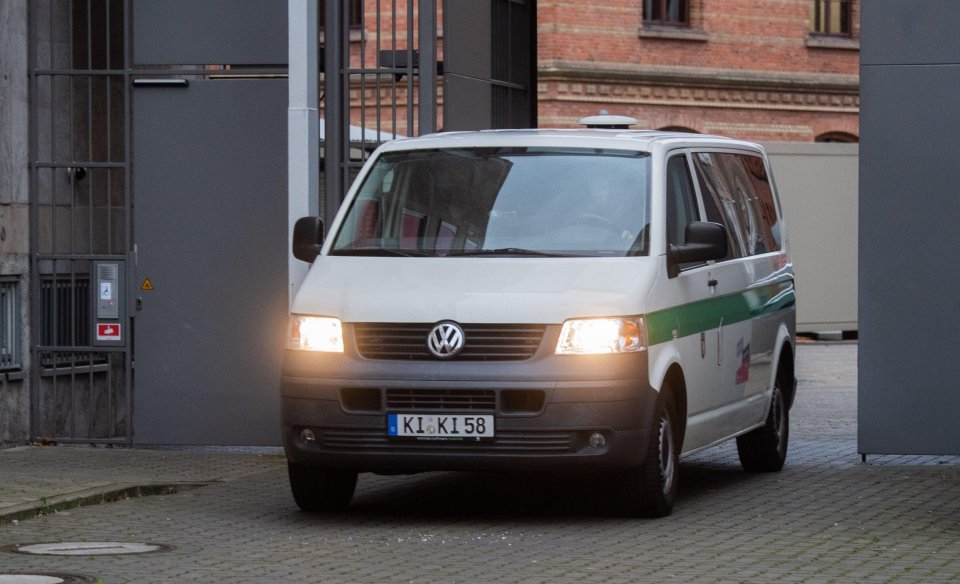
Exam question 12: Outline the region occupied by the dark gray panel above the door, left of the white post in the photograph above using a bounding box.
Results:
[133,0,287,65]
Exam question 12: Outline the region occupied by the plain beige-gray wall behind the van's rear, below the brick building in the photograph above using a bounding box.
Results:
[765,143,859,333]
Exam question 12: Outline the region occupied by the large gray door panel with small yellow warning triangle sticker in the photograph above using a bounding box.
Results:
[133,79,289,446]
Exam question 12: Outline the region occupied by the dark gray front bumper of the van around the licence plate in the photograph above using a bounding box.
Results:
[281,335,657,472]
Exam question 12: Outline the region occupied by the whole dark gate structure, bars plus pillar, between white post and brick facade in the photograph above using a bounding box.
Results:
[320,0,536,218]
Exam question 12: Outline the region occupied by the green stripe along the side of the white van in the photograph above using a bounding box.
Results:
[644,280,796,345]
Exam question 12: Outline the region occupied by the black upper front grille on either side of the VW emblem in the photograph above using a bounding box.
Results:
[353,323,547,361]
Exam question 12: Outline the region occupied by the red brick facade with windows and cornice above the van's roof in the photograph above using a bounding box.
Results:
[537,0,860,142]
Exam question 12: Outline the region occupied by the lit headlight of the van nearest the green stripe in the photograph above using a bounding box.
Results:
[556,317,647,355]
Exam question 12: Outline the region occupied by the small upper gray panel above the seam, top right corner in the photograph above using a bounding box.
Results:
[860,0,960,65]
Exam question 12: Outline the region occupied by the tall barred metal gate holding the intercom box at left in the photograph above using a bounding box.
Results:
[28,0,132,443]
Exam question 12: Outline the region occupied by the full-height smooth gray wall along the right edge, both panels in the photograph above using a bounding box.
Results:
[858,0,960,454]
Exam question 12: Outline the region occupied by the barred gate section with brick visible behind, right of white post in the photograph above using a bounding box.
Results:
[319,0,439,219]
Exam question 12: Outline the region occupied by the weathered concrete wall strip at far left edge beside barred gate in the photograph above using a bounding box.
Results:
[0,0,30,447]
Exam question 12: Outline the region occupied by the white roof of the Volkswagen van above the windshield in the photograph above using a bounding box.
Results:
[382,128,759,151]
